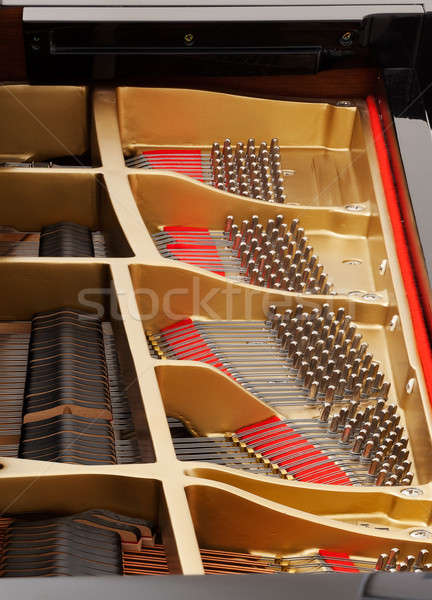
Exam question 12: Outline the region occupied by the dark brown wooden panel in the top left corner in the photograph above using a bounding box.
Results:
[0,8,27,81]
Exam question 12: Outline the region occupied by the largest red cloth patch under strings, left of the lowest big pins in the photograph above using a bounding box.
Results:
[236,416,352,485]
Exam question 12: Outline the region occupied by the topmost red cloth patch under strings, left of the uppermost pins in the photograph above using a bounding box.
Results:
[142,148,204,182]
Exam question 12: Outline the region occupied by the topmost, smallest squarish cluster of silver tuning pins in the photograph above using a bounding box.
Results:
[210,138,286,203]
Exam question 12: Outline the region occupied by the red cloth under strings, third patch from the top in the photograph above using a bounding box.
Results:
[161,319,231,377]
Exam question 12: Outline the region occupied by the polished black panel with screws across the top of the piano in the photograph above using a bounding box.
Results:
[24,12,422,83]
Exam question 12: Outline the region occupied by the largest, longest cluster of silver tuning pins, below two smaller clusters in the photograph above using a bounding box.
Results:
[267,304,413,485]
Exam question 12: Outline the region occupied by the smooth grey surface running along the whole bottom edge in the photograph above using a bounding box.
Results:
[0,573,432,600]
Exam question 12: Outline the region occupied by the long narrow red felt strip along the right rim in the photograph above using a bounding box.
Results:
[367,96,432,402]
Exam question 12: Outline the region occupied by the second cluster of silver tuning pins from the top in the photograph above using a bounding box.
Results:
[224,215,331,294]
